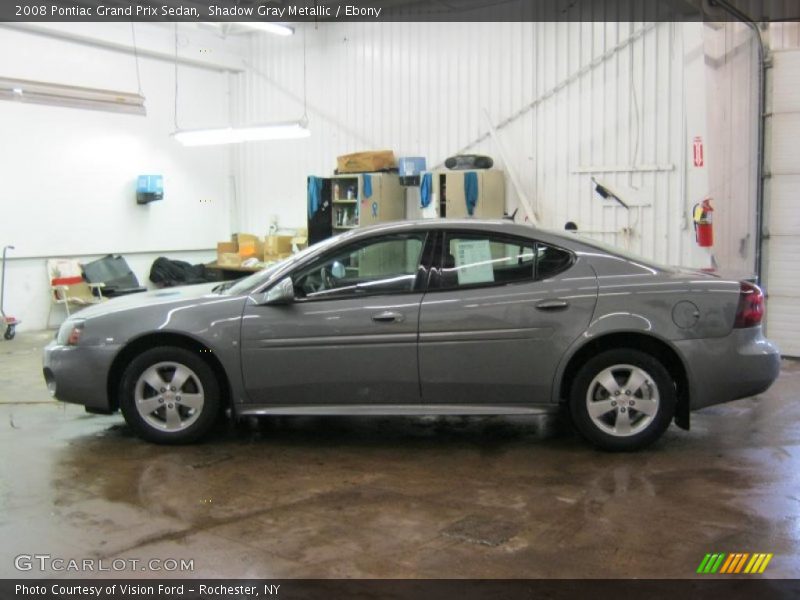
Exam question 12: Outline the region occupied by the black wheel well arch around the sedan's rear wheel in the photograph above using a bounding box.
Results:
[559,333,689,429]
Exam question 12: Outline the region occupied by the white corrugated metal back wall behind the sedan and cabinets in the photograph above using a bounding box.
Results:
[233,22,704,265]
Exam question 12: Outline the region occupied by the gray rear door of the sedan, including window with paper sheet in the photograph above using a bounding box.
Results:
[419,232,597,405]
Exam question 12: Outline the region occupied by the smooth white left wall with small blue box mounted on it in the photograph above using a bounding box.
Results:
[0,24,242,329]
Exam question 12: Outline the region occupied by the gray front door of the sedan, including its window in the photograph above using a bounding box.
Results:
[241,232,427,405]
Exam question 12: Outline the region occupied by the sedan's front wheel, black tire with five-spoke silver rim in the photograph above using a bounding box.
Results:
[119,346,222,444]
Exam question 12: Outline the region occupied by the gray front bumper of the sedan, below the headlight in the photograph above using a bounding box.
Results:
[42,341,119,412]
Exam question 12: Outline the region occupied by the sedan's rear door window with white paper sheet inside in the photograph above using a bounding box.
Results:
[439,233,572,289]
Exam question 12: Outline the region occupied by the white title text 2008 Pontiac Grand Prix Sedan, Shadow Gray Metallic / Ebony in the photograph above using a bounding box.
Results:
[36,4,383,19]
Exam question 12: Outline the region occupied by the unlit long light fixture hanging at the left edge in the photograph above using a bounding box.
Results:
[0,77,146,115]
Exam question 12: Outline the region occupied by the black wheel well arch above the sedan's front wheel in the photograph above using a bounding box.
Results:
[106,333,231,410]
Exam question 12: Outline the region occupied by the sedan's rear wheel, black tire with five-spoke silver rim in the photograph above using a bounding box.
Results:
[569,348,677,452]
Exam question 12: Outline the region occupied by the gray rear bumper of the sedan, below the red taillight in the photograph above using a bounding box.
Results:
[675,327,781,410]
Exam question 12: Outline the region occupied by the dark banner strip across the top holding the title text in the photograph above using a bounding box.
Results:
[0,0,800,22]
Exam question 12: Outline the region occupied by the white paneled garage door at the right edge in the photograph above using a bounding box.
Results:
[765,50,800,356]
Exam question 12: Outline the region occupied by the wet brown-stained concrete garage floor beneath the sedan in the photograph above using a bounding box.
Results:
[0,333,800,578]
